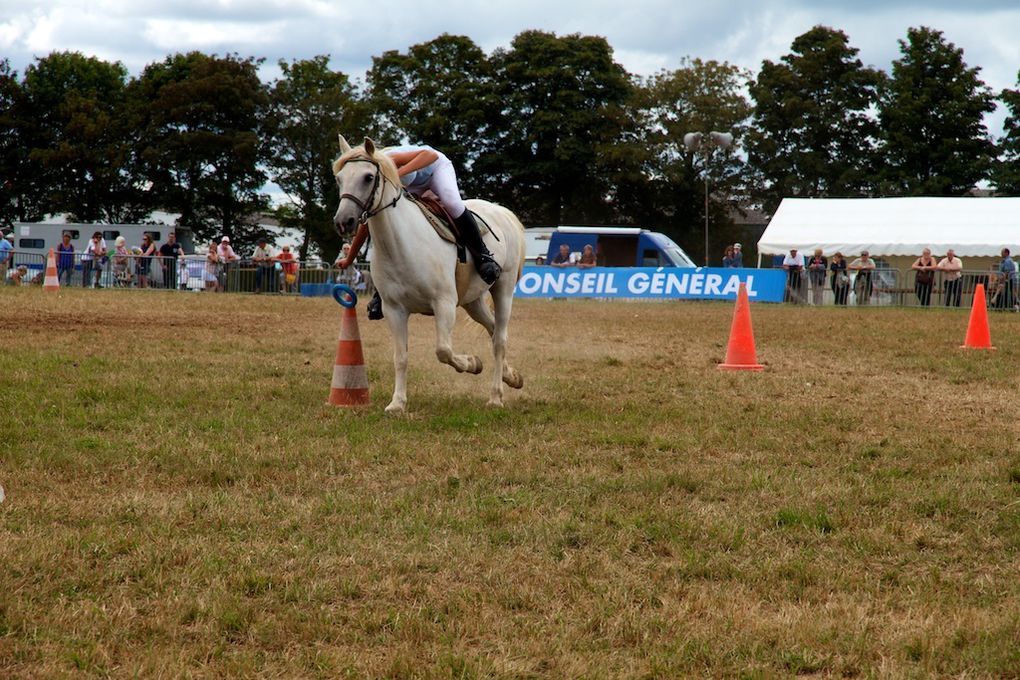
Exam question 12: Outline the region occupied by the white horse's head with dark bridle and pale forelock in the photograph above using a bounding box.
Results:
[333,135,400,234]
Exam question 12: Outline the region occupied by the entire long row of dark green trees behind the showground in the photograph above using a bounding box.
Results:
[0,27,1007,257]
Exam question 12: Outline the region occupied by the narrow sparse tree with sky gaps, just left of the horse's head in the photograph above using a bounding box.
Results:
[267,56,367,260]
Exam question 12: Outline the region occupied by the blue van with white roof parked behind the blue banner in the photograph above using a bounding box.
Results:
[546,226,697,267]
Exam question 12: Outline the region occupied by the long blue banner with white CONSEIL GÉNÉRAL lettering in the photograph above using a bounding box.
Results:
[514,266,786,302]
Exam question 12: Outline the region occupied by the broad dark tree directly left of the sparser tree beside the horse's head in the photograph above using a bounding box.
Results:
[130,52,268,243]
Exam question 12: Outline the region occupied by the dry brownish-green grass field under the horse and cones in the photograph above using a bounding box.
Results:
[0,289,1020,678]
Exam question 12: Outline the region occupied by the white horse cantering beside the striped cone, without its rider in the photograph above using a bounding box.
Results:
[333,136,524,413]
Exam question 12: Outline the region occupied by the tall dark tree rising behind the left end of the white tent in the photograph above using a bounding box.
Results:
[747,27,882,211]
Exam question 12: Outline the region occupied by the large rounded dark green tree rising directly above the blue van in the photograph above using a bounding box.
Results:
[472,31,633,224]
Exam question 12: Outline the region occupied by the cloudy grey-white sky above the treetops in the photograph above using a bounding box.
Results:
[0,0,1020,134]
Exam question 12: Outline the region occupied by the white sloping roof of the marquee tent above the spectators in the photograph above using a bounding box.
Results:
[758,197,1020,257]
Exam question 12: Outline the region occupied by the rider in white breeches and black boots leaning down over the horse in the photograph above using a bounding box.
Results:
[338,145,502,319]
